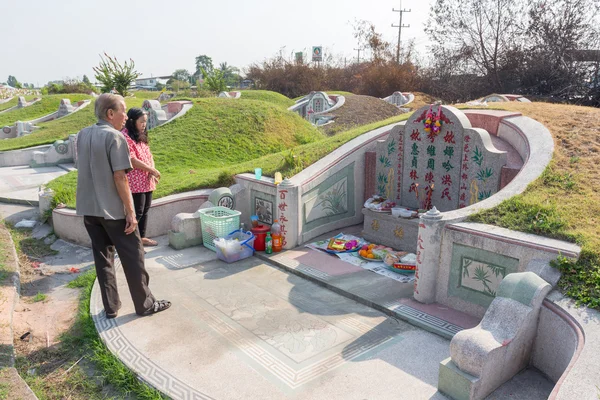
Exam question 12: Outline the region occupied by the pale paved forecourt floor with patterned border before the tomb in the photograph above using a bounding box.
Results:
[91,238,552,400]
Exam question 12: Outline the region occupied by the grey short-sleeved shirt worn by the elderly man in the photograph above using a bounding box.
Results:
[77,121,132,219]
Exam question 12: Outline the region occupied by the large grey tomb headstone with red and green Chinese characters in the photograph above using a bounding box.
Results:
[376,105,507,212]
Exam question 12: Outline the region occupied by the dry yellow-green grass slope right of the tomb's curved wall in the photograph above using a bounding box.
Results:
[472,103,600,309]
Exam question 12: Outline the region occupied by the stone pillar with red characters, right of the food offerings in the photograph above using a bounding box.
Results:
[414,207,444,304]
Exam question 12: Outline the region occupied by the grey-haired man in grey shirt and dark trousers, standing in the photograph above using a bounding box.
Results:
[77,93,171,318]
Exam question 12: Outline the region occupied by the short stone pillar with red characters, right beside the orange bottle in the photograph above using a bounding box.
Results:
[275,178,301,249]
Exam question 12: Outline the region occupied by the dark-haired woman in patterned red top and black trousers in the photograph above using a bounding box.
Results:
[122,108,160,246]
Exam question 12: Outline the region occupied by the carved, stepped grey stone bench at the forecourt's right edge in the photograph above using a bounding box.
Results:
[438,272,551,400]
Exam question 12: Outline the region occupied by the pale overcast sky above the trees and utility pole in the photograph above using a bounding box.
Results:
[0,0,432,86]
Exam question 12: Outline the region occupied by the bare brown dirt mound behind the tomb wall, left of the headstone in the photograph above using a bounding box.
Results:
[322,95,401,135]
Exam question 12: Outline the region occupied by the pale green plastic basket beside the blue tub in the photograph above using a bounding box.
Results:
[198,207,242,251]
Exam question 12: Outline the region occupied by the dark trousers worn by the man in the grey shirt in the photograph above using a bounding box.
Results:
[84,216,155,315]
